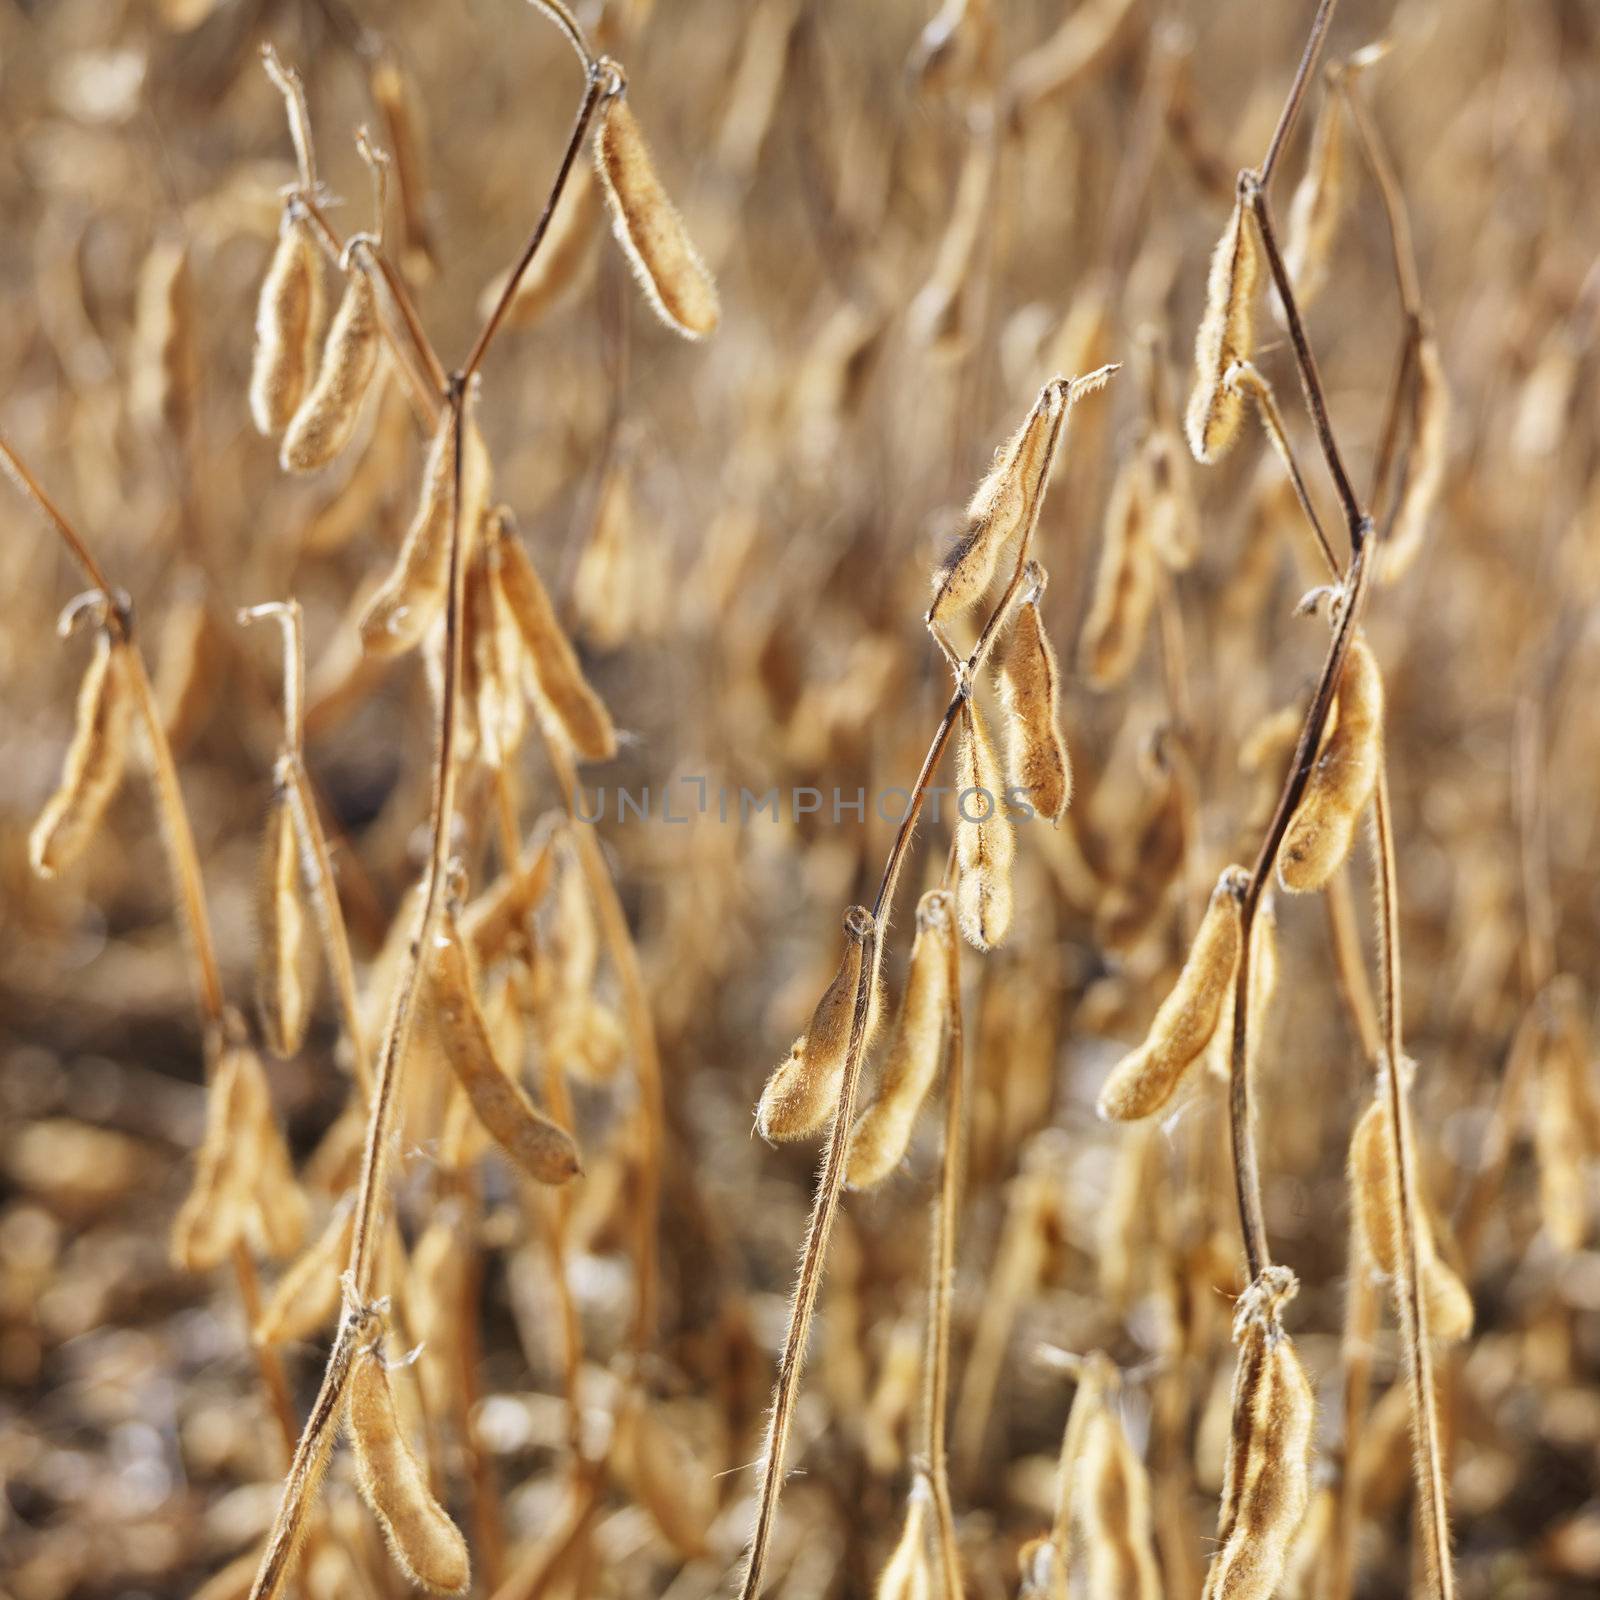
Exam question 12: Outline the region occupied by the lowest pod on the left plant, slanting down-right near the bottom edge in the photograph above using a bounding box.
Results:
[344,1346,470,1595]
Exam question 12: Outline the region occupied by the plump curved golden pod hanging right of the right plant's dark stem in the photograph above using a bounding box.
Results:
[1278,635,1384,894]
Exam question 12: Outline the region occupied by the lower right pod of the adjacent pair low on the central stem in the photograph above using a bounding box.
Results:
[845,890,954,1189]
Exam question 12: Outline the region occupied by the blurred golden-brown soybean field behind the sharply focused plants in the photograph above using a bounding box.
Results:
[0,0,1600,1600]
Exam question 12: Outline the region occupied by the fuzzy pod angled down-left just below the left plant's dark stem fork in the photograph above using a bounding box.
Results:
[360,419,488,656]
